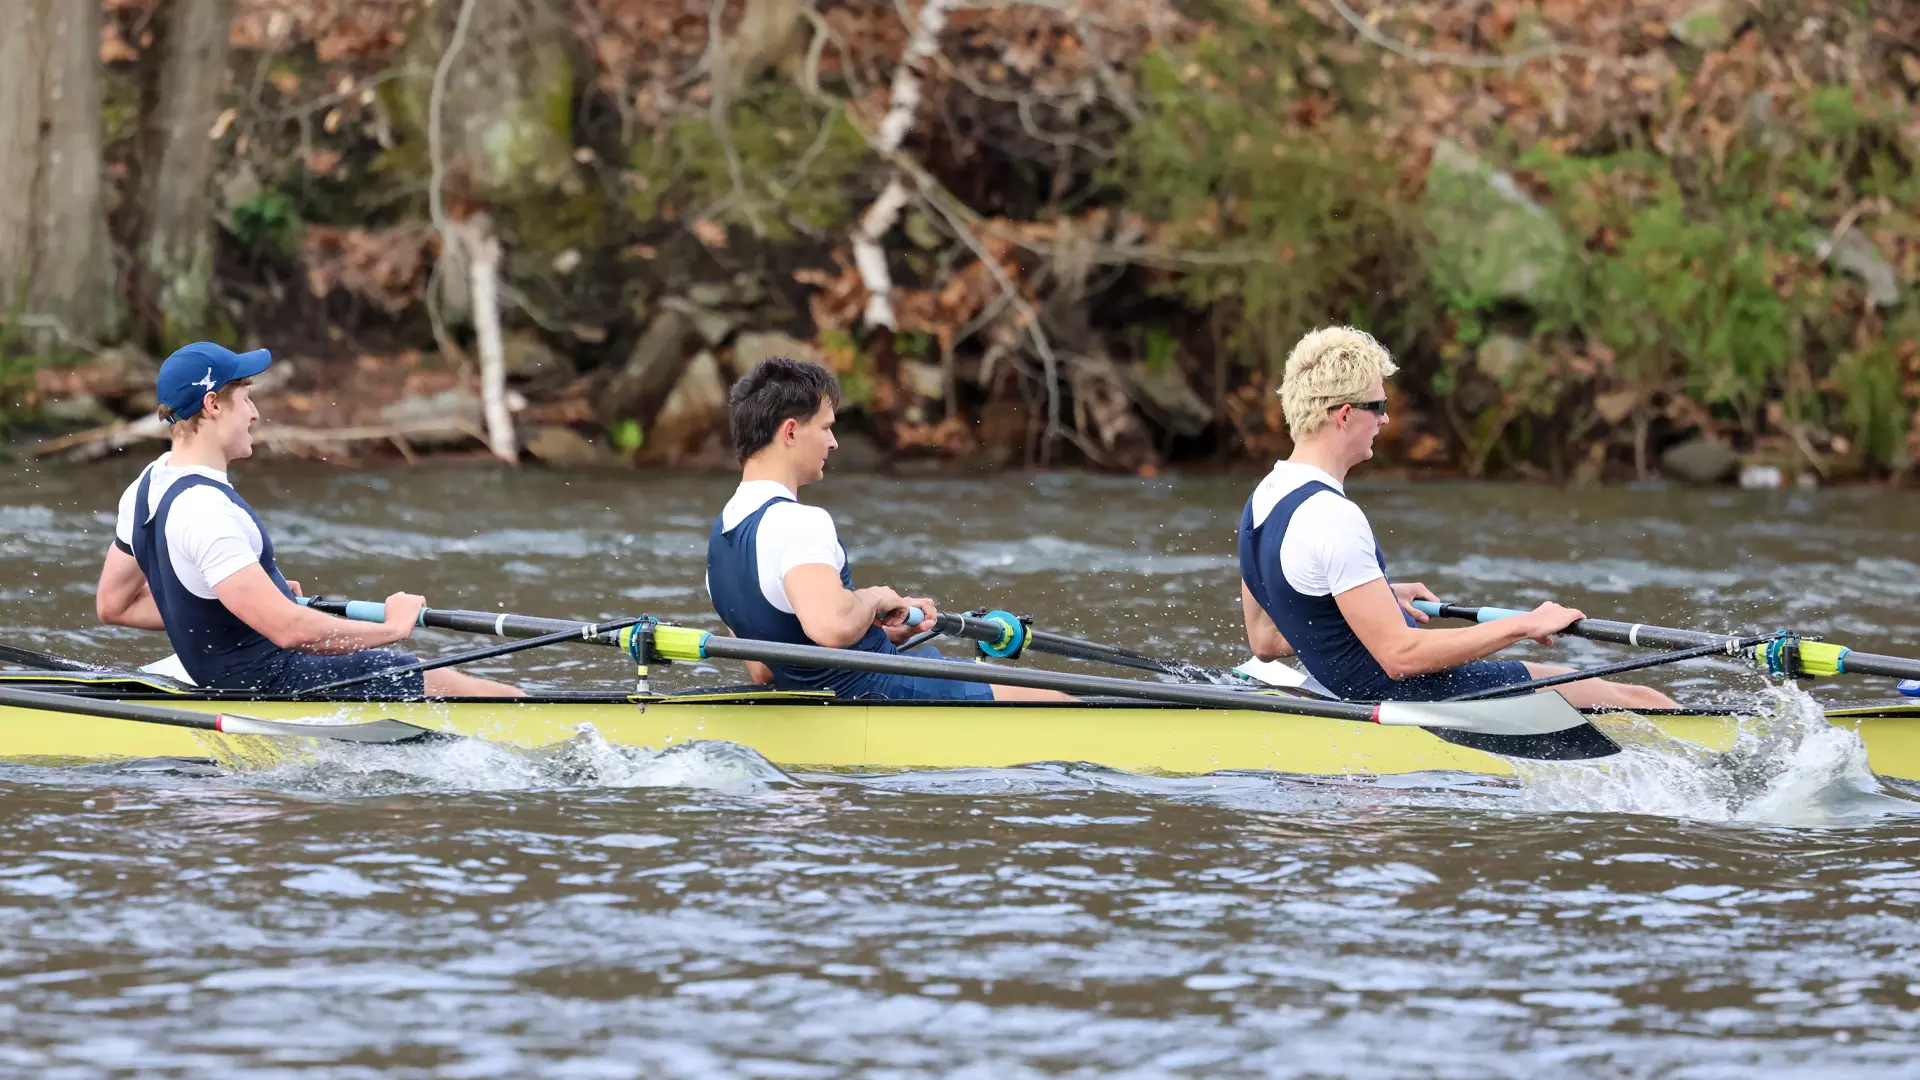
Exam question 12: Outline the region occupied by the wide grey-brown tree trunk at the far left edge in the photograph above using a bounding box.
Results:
[0,0,117,350]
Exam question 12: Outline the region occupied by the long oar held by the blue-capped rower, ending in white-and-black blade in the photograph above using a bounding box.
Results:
[311,600,1620,761]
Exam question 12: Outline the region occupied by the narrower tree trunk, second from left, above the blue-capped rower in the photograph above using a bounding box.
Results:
[131,0,234,346]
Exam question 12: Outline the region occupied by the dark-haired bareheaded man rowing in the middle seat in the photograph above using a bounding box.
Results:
[707,359,1068,701]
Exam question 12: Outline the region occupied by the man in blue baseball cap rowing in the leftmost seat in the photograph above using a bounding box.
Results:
[94,342,522,698]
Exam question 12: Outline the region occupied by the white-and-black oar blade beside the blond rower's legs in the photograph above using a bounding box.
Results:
[1377,692,1620,761]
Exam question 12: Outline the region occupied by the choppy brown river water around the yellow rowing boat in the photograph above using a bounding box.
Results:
[0,459,1920,1078]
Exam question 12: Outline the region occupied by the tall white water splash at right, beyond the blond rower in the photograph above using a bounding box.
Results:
[1515,686,1920,826]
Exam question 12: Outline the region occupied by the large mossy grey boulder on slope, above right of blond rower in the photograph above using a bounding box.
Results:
[1421,138,1571,304]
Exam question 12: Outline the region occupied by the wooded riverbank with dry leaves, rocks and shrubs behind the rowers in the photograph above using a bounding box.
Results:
[0,0,1920,484]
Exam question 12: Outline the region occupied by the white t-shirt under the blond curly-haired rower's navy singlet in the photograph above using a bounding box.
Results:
[1254,461,1386,596]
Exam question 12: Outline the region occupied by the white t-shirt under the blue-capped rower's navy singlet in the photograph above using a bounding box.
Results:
[113,454,263,600]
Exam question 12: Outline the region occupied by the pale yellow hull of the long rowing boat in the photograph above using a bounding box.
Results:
[0,682,1920,780]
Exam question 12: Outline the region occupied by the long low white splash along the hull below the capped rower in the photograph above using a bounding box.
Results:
[202,724,795,798]
